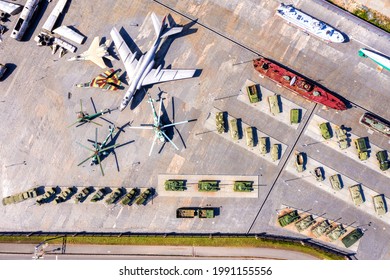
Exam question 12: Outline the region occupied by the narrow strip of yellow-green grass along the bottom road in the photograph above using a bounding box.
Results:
[0,236,345,260]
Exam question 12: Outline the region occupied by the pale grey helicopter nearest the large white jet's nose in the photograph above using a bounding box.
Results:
[130,93,190,156]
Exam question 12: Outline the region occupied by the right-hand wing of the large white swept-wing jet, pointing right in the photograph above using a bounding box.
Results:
[142,69,196,86]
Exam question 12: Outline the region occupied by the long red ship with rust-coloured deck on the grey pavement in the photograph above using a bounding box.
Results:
[253,58,347,110]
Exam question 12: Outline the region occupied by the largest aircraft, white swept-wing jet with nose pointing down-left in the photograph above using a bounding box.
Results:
[110,13,200,111]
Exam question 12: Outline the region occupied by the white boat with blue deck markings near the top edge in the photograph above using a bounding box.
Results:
[276,3,345,43]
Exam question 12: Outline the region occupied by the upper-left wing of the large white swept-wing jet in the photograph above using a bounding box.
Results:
[110,27,138,78]
